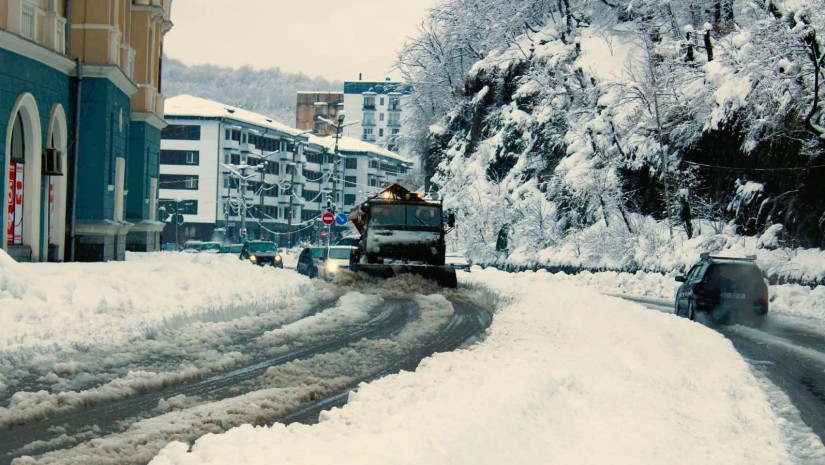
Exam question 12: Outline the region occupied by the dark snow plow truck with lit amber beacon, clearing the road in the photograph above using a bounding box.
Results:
[349,184,458,288]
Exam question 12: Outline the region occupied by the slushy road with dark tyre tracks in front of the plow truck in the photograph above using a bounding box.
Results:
[0,258,492,465]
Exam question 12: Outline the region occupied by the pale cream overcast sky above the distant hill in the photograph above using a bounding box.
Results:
[164,0,441,80]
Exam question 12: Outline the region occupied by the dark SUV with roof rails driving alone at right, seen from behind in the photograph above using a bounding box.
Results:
[675,254,768,326]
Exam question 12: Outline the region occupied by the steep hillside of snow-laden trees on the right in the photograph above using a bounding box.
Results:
[399,0,825,276]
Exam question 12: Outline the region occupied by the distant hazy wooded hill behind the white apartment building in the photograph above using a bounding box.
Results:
[163,57,344,126]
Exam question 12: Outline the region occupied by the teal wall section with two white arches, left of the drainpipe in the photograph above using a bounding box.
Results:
[0,34,75,261]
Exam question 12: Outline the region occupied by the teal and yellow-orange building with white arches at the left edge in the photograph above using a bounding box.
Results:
[0,0,171,262]
